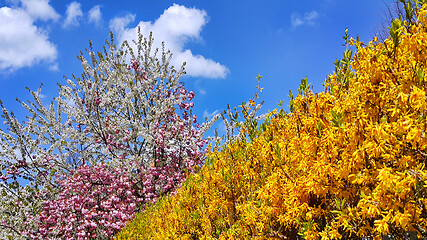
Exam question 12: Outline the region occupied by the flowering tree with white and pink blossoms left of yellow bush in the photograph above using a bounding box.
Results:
[0,31,218,239]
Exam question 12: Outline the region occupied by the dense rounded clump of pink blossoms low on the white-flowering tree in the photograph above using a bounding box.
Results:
[31,164,141,239]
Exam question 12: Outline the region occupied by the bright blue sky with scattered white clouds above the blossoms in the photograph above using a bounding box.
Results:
[0,0,394,134]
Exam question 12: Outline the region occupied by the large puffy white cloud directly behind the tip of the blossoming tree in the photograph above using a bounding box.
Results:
[110,4,229,78]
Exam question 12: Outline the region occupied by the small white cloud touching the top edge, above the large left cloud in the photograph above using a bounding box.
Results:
[21,0,60,21]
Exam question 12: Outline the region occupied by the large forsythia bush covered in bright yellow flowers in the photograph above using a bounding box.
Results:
[116,0,427,239]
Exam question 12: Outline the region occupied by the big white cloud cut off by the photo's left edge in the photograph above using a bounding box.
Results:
[0,7,57,71]
